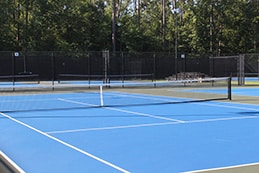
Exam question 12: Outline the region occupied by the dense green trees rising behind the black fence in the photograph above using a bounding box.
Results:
[0,0,259,55]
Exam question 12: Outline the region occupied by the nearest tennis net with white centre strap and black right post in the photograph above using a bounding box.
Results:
[0,78,231,112]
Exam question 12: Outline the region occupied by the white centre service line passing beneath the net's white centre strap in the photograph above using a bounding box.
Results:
[58,98,184,123]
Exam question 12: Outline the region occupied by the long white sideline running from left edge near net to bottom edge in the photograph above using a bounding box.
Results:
[0,112,130,173]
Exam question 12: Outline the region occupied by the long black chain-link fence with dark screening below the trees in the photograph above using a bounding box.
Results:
[0,51,259,81]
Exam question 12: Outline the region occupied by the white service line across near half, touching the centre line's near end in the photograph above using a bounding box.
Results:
[45,116,259,134]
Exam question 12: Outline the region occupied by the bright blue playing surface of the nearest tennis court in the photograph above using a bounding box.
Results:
[0,92,259,173]
